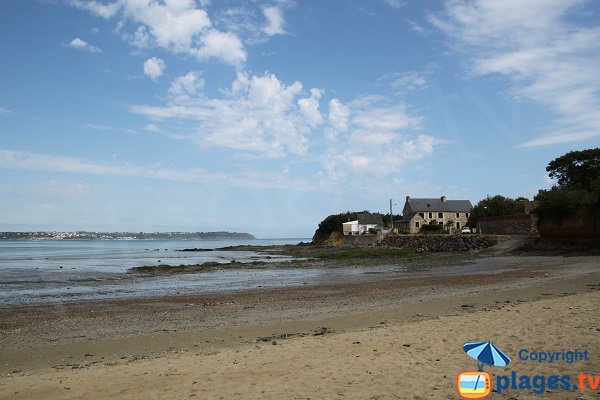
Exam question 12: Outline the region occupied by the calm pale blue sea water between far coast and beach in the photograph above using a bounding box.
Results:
[0,239,311,307]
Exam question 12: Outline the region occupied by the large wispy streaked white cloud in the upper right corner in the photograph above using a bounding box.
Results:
[430,0,600,147]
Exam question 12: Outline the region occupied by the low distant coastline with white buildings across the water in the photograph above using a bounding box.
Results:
[0,231,256,240]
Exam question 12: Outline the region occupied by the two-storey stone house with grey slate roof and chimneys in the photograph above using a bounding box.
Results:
[394,196,473,233]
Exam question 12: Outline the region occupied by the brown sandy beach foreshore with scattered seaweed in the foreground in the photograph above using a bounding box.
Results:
[0,256,600,399]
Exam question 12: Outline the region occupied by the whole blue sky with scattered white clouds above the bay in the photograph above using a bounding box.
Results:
[0,0,600,237]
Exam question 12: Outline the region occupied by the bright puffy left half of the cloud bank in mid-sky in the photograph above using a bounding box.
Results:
[131,73,322,158]
